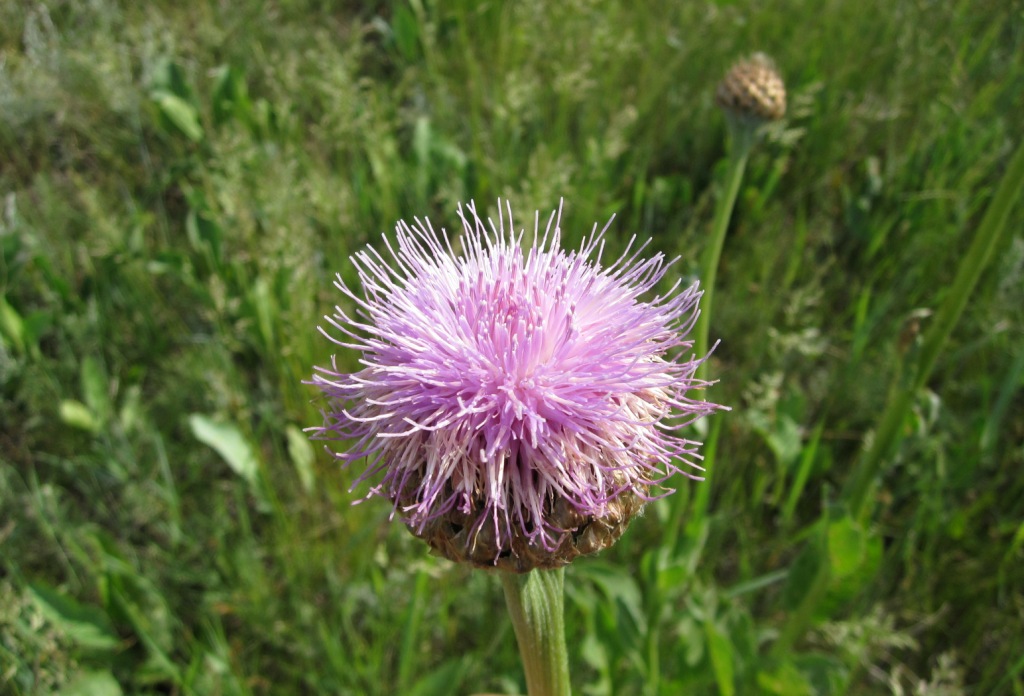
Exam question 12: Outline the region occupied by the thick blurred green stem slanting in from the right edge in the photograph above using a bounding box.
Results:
[846,142,1024,519]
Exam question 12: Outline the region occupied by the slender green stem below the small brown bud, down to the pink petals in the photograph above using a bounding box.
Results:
[694,119,755,378]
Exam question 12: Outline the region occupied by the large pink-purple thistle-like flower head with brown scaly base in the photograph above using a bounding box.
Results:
[310,202,722,572]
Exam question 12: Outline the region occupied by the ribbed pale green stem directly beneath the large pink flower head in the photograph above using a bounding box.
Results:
[500,568,571,696]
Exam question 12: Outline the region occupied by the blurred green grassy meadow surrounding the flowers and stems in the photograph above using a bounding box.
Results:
[0,0,1024,696]
